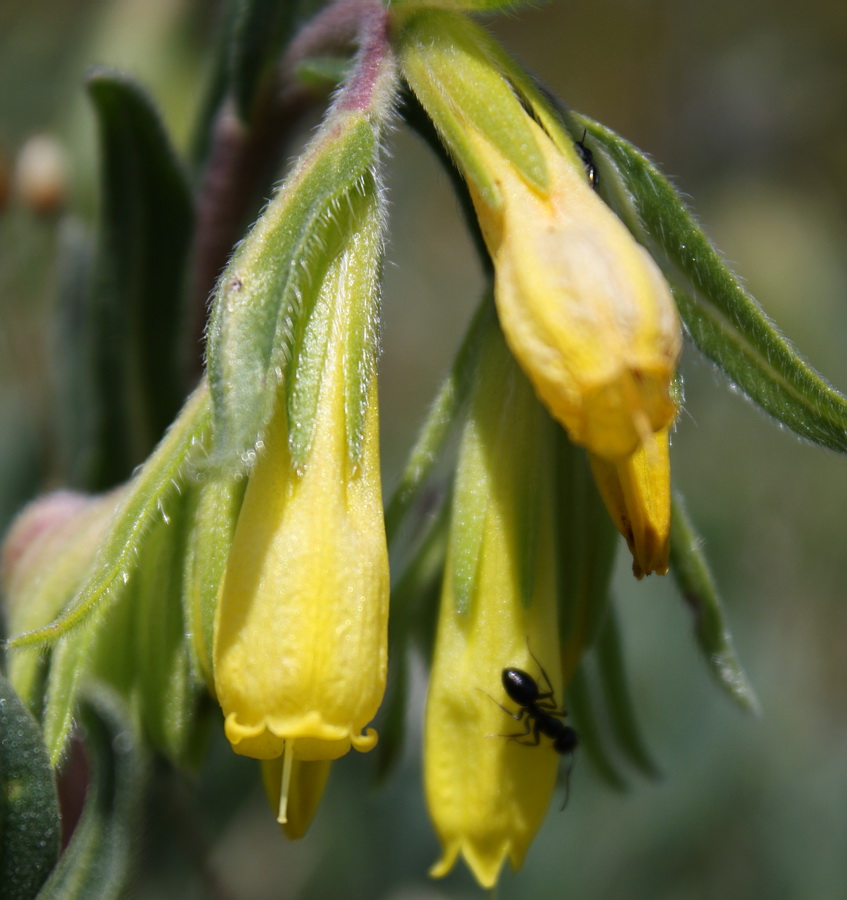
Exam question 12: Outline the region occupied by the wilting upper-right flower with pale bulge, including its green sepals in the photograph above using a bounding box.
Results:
[400,10,682,460]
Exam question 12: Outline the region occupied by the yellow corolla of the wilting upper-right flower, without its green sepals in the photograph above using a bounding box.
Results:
[468,121,682,460]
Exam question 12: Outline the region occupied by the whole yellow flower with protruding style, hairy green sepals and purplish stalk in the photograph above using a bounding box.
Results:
[209,15,396,833]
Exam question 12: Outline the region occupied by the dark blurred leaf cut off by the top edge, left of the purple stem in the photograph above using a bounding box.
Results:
[229,0,301,122]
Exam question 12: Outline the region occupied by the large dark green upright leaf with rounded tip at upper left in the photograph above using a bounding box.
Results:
[80,70,194,490]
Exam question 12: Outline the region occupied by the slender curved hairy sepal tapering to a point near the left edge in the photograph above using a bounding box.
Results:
[9,381,211,647]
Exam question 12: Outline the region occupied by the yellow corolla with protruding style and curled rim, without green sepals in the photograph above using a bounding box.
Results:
[214,232,388,800]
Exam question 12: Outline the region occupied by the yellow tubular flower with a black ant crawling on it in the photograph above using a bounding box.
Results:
[424,330,562,887]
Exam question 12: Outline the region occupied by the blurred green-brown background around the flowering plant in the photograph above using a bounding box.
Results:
[0,0,847,900]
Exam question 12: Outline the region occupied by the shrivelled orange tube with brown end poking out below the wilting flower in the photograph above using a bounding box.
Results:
[589,428,671,578]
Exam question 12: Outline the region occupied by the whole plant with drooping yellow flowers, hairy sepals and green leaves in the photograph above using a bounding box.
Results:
[0,0,847,898]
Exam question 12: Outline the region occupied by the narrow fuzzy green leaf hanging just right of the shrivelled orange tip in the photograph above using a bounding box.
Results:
[670,492,760,715]
